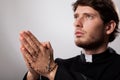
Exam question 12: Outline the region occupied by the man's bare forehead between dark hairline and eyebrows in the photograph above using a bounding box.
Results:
[74,6,99,15]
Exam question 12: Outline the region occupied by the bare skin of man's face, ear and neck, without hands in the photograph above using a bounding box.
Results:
[74,6,115,54]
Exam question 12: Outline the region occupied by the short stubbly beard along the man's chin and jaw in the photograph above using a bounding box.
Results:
[75,34,106,50]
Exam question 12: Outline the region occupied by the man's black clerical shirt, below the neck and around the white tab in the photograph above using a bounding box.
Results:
[24,48,120,80]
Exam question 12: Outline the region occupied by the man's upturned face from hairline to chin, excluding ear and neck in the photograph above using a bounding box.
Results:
[74,6,105,49]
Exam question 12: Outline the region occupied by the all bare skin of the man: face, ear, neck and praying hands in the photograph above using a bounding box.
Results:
[20,6,116,80]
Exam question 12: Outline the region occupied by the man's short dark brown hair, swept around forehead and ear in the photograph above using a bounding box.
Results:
[73,0,119,42]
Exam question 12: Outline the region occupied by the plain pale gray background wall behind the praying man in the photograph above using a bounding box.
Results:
[0,0,120,80]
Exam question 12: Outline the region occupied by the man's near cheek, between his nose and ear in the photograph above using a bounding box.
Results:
[83,18,105,38]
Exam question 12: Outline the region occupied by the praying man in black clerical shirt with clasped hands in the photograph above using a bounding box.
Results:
[20,0,120,80]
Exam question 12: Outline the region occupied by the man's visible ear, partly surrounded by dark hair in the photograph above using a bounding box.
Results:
[106,20,116,35]
